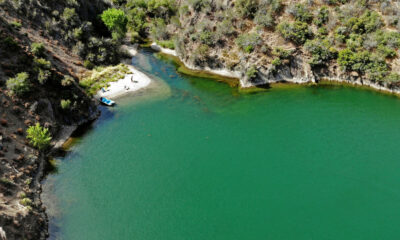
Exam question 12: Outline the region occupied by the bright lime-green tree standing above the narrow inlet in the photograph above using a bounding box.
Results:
[101,8,128,39]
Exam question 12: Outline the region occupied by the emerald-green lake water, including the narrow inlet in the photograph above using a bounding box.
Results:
[45,51,400,240]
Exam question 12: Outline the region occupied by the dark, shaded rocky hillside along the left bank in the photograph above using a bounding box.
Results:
[0,0,112,240]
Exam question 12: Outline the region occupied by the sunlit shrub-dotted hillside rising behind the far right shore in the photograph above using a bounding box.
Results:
[122,0,400,88]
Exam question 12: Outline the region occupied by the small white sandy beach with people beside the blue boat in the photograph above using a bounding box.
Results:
[96,65,151,98]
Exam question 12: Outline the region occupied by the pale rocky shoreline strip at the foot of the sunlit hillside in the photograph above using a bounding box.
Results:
[151,42,400,97]
